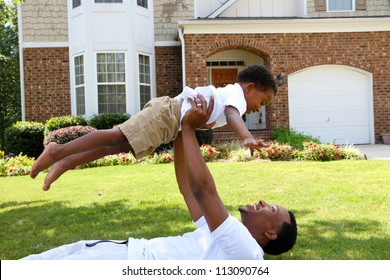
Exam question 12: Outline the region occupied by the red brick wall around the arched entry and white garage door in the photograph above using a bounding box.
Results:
[185,32,390,142]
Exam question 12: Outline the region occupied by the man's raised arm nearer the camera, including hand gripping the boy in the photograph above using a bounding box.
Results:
[182,95,229,231]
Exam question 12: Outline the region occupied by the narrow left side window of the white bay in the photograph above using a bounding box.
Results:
[73,54,85,116]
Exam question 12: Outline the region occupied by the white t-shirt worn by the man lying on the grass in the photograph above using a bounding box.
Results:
[127,215,264,260]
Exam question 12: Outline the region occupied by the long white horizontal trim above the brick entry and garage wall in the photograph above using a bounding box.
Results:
[178,17,390,34]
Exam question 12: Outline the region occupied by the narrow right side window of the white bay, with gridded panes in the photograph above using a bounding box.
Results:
[138,54,151,110]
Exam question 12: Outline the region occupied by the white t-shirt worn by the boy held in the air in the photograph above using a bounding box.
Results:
[175,83,247,129]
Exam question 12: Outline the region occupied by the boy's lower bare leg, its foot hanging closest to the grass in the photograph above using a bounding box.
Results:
[42,143,134,191]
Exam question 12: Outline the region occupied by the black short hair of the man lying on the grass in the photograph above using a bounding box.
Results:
[263,211,298,255]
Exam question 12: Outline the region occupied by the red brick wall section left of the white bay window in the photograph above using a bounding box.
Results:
[23,48,71,122]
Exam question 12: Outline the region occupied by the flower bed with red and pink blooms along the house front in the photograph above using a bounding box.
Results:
[0,141,364,176]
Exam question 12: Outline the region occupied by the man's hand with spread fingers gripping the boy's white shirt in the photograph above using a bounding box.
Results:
[182,94,214,129]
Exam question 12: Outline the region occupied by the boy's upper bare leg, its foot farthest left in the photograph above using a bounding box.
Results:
[30,128,128,178]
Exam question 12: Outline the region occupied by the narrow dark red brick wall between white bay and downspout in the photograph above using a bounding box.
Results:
[155,46,183,97]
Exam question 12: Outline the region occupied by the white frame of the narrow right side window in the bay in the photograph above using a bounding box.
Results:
[138,53,152,110]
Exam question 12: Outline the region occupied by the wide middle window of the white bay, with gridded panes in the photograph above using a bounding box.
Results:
[96,53,126,114]
